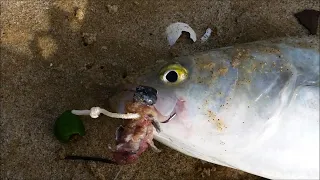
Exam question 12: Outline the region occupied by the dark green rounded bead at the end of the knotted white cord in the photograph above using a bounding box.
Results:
[54,110,85,143]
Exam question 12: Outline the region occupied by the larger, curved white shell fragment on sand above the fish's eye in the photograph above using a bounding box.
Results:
[166,22,197,46]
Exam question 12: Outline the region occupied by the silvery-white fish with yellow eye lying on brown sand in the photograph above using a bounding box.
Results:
[113,36,319,179]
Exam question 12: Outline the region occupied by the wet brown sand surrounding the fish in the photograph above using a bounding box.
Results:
[0,0,319,180]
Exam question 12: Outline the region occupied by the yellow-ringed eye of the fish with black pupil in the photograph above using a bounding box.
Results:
[160,63,188,84]
